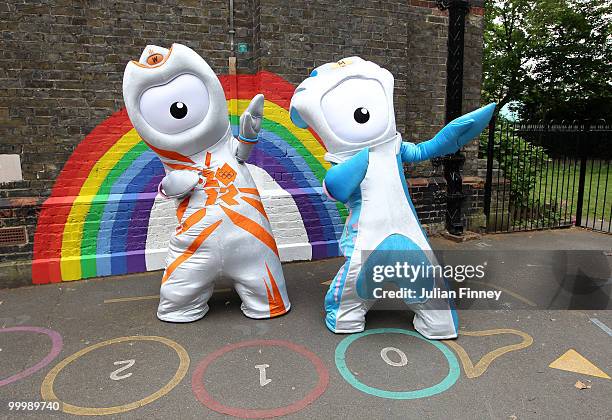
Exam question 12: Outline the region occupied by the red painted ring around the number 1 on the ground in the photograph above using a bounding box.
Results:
[191,340,329,419]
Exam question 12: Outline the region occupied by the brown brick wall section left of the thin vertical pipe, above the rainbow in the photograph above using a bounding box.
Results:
[0,0,234,263]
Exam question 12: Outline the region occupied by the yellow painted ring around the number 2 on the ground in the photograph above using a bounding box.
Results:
[40,336,189,416]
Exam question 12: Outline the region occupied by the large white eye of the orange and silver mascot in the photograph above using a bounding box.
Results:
[140,74,210,134]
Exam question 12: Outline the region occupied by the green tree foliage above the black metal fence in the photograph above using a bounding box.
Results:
[483,0,612,120]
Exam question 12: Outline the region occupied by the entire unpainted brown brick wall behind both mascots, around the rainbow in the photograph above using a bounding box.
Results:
[0,0,482,284]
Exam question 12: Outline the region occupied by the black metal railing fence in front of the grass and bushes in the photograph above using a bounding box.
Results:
[480,119,612,233]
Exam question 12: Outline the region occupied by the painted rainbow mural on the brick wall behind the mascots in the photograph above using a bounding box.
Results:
[32,72,346,284]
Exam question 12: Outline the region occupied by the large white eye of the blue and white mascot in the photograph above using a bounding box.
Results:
[321,78,389,143]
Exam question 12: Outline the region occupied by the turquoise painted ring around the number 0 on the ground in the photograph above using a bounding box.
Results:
[336,328,461,400]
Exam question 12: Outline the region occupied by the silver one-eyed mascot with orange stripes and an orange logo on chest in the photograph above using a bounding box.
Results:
[123,44,290,322]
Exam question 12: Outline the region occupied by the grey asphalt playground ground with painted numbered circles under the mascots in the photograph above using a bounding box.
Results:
[0,229,612,419]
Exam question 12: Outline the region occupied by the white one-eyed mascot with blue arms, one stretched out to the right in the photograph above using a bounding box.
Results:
[290,57,495,339]
